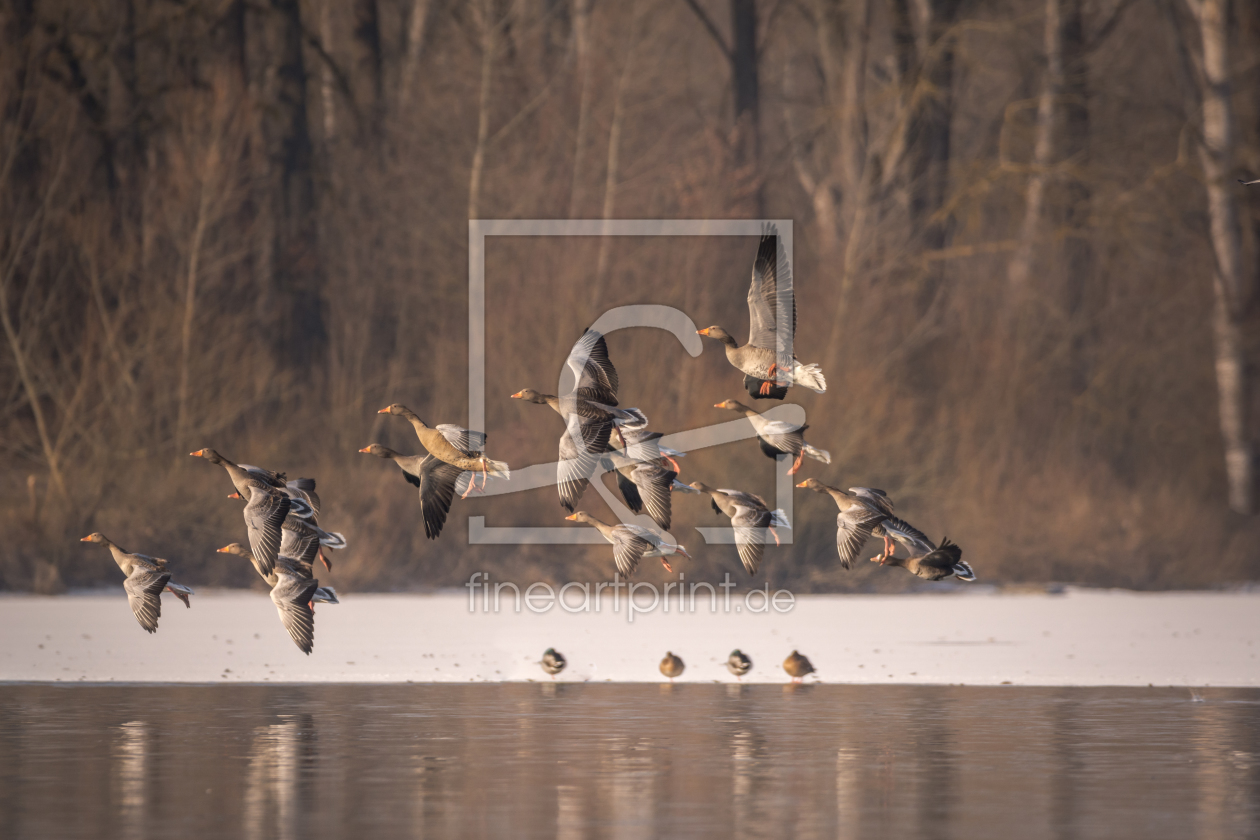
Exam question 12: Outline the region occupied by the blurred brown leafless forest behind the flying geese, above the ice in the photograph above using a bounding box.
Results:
[0,0,1260,592]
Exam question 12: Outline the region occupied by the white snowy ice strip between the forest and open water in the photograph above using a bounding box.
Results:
[0,586,1260,686]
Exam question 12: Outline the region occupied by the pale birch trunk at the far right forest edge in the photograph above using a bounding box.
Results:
[1191,0,1255,514]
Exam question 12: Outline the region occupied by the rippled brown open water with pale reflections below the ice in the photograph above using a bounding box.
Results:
[0,684,1260,840]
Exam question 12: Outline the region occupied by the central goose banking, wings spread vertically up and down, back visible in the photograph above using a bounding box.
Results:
[512,330,648,513]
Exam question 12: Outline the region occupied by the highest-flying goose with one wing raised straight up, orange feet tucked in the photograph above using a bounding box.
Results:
[697,225,827,399]
